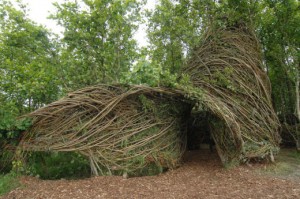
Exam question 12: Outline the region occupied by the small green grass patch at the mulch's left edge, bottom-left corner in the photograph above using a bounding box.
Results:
[0,173,21,196]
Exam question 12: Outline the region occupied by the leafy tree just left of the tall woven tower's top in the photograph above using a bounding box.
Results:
[146,0,201,74]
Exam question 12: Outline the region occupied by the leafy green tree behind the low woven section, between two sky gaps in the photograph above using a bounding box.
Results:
[52,0,140,88]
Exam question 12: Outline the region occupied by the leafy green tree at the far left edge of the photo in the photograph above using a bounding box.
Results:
[0,1,59,114]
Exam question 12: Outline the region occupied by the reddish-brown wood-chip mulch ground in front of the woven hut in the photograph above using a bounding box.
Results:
[2,151,300,199]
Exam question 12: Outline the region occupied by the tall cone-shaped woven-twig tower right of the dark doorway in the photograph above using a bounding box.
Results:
[183,25,280,163]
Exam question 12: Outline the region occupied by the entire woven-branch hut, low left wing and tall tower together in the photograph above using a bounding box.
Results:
[20,23,280,175]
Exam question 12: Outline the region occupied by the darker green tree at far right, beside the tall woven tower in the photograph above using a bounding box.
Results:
[258,0,300,117]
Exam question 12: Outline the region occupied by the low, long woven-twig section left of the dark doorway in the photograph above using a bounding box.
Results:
[20,85,186,175]
